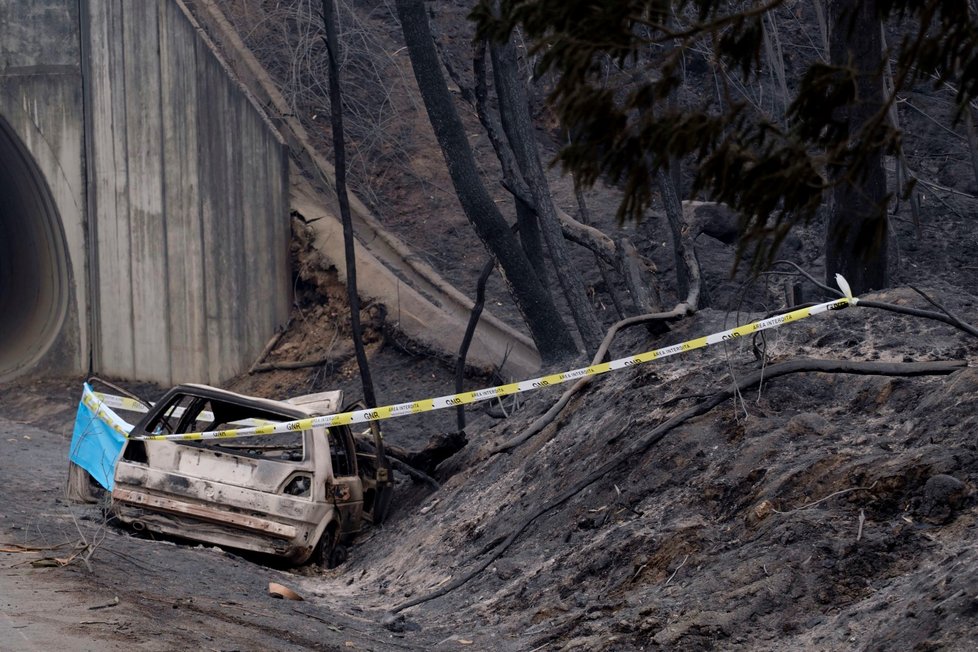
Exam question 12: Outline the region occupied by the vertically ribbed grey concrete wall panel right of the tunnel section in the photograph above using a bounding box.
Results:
[82,0,291,383]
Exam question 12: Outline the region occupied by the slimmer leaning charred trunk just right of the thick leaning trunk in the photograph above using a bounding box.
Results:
[490,36,603,355]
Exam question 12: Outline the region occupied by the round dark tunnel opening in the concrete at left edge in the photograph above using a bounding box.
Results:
[0,117,68,380]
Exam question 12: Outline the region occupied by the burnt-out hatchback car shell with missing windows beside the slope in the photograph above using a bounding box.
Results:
[69,385,392,567]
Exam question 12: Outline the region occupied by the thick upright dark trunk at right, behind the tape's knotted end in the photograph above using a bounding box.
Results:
[825,0,888,294]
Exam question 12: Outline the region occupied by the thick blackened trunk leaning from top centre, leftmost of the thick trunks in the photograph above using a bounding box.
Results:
[397,0,577,362]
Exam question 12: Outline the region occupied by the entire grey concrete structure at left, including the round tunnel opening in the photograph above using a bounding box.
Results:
[0,0,291,383]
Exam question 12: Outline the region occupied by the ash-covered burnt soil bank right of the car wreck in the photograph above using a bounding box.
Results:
[292,291,978,650]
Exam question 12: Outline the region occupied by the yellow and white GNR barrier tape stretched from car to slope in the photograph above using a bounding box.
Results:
[102,275,858,441]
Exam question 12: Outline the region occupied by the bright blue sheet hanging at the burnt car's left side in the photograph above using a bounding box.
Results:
[68,383,132,491]
